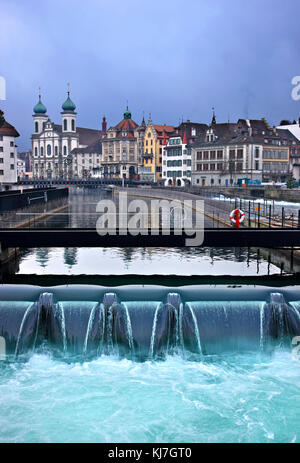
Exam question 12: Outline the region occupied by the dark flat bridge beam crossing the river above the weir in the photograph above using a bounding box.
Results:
[0,228,300,248]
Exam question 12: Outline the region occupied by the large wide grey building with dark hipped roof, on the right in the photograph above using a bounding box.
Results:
[191,116,289,186]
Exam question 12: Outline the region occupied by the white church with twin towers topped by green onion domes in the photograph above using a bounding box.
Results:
[31,91,106,179]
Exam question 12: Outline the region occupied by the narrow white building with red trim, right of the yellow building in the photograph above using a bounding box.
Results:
[162,133,192,186]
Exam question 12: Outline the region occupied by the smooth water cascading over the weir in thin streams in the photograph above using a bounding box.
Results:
[0,285,300,361]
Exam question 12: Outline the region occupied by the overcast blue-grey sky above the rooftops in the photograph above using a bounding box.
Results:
[0,0,300,150]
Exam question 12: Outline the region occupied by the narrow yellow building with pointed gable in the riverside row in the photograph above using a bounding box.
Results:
[139,119,175,182]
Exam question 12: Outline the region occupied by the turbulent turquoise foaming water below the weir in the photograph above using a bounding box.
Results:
[0,351,300,443]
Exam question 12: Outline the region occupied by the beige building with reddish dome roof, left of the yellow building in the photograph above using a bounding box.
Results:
[102,107,144,178]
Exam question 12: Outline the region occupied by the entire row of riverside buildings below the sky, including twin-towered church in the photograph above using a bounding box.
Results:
[0,91,300,187]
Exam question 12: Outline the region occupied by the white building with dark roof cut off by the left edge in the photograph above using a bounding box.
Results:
[0,110,20,190]
